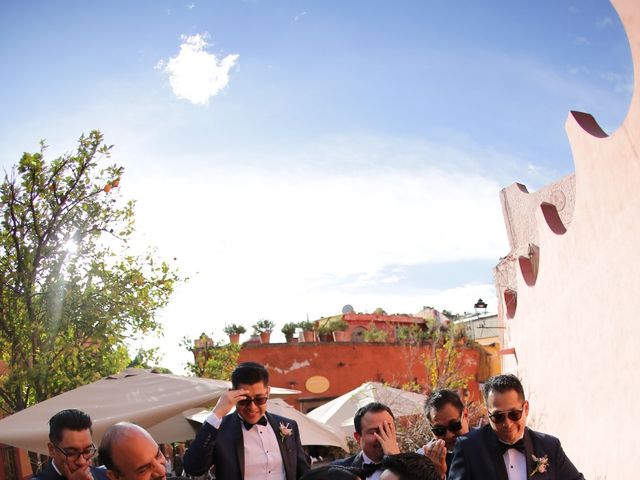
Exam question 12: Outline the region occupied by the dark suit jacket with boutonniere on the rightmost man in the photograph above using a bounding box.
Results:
[448,425,584,480]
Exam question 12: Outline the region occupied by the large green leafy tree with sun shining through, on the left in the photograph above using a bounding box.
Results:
[0,131,178,412]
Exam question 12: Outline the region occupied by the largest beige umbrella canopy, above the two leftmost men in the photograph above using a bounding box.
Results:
[0,368,299,454]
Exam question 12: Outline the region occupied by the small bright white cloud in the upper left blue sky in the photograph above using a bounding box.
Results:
[156,34,239,105]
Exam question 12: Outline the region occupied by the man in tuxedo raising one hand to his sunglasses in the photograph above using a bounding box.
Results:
[184,362,309,480]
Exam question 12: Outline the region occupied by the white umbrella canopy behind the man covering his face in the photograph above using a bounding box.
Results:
[307,382,427,435]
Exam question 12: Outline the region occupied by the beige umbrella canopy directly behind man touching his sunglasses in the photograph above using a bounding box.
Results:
[184,398,349,452]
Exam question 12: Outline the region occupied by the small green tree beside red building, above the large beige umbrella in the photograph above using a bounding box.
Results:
[181,333,241,380]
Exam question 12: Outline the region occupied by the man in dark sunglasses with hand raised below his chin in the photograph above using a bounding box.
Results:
[418,388,469,478]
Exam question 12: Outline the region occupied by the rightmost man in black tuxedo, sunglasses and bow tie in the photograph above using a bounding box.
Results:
[449,375,584,480]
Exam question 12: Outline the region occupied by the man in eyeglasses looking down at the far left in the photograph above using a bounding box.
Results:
[33,409,107,480]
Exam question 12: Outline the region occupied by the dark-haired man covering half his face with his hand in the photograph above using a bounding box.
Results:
[333,402,400,480]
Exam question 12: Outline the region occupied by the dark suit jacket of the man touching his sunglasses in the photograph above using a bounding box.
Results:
[183,412,309,480]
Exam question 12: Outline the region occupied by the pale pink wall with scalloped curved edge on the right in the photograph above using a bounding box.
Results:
[496,0,640,479]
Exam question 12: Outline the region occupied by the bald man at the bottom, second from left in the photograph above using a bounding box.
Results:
[99,422,167,480]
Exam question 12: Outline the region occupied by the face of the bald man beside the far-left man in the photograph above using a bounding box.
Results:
[107,428,167,480]
